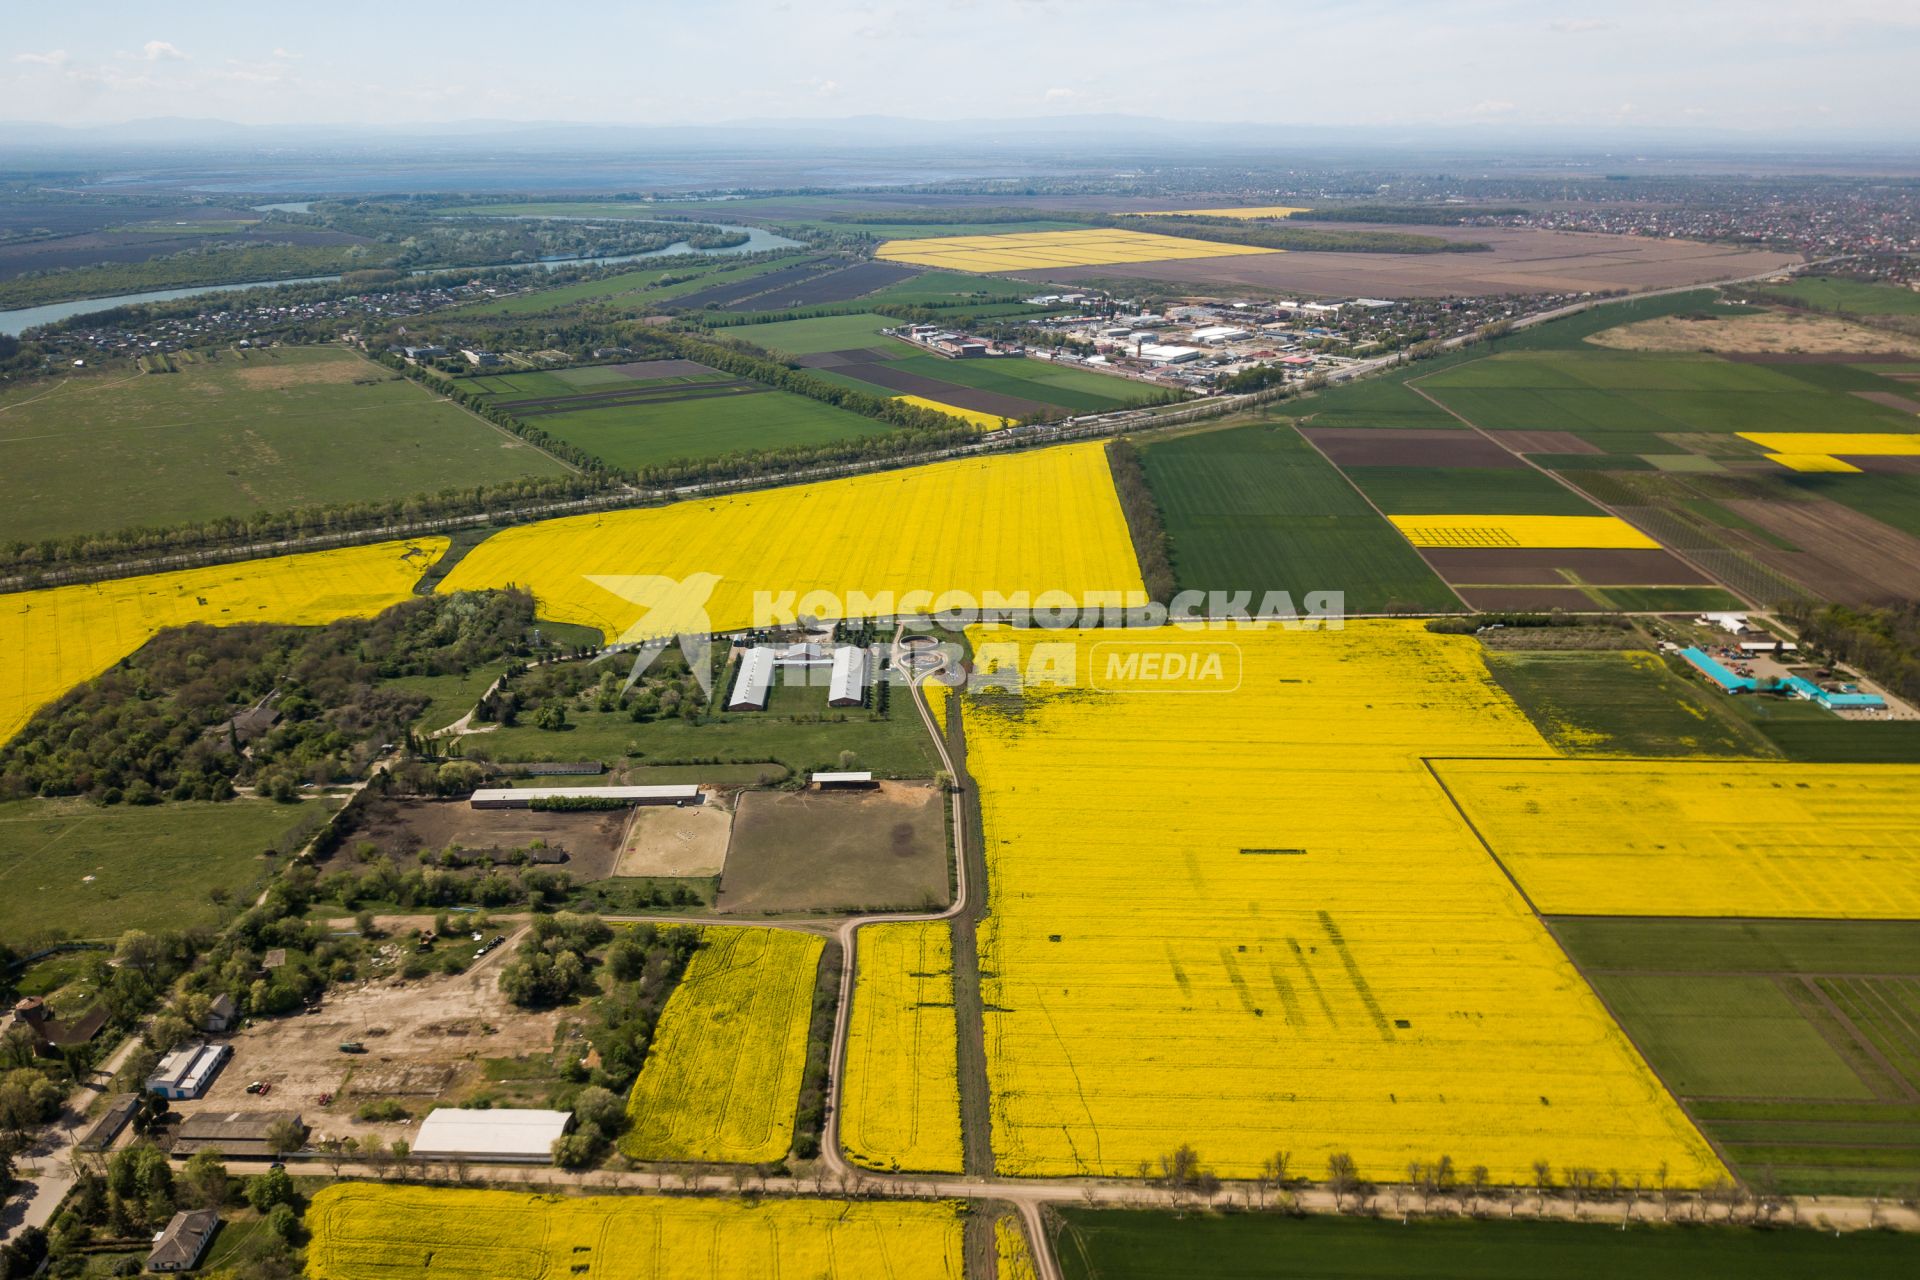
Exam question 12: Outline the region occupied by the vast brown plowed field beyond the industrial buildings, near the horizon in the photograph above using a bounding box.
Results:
[1014,223,1801,297]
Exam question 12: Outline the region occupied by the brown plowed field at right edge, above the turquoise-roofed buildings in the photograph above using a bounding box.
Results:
[1726,499,1920,603]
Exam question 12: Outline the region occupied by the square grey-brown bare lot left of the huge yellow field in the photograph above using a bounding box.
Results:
[718,783,948,912]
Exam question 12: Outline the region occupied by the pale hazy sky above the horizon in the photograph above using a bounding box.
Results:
[0,0,1920,138]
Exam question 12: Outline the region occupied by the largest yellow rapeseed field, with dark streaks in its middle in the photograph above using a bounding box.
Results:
[964,622,1724,1184]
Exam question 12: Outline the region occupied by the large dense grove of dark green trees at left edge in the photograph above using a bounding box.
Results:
[0,591,534,804]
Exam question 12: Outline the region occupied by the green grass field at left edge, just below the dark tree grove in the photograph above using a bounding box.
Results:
[0,800,323,942]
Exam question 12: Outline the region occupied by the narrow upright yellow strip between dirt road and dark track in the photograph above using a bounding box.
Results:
[839,919,962,1173]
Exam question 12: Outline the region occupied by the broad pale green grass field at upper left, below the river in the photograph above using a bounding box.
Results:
[0,347,563,541]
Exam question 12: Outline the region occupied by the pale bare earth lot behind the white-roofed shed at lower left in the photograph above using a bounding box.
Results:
[175,940,561,1140]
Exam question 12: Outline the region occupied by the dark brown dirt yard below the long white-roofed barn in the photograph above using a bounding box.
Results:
[348,800,630,883]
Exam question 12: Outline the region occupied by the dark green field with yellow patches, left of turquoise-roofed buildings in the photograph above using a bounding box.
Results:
[1486,651,1774,758]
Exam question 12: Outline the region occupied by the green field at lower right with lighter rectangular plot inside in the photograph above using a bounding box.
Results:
[1551,919,1920,1196]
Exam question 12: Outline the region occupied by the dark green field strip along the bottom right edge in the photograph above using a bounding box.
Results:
[1056,1212,1920,1280]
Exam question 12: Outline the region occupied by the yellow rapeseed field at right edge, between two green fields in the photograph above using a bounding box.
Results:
[1434,760,1920,919]
